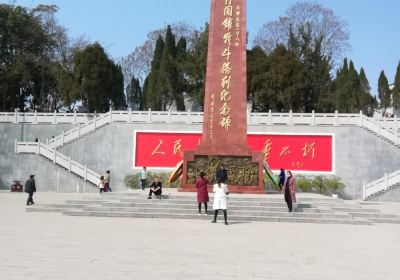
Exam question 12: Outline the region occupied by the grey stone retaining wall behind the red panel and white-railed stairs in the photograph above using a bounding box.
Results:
[0,123,400,198]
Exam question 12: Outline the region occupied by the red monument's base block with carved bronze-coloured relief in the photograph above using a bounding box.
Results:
[180,150,264,194]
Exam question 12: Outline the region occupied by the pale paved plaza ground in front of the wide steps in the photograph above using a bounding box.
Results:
[0,192,400,280]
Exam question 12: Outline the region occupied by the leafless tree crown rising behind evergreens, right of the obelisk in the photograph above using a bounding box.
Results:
[253,2,350,65]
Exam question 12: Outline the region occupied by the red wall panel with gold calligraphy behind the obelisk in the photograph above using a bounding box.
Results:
[134,131,334,173]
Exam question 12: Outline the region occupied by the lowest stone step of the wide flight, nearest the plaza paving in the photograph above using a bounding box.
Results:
[63,210,373,225]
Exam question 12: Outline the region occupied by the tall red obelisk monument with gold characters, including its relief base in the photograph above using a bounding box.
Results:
[182,0,262,192]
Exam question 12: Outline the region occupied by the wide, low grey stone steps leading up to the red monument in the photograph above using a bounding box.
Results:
[26,192,400,225]
